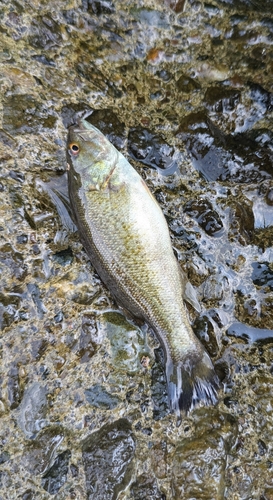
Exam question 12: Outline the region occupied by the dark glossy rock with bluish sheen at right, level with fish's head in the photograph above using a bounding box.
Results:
[177,111,273,183]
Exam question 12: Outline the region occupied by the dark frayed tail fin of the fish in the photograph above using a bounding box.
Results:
[166,350,220,415]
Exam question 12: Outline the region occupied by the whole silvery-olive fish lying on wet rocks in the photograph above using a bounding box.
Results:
[67,118,219,415]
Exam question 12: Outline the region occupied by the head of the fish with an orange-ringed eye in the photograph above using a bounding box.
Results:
[67,119,119,182]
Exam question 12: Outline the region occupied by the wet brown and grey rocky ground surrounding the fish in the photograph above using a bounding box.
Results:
[0,0,273,500]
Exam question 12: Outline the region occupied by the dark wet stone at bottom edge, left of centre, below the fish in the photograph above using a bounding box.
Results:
[82,418,135,500]
